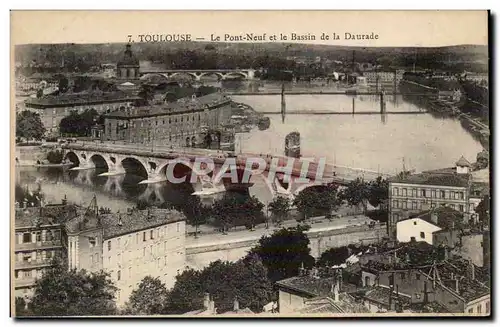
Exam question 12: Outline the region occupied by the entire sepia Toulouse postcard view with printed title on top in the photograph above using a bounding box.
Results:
[5,10,492,319]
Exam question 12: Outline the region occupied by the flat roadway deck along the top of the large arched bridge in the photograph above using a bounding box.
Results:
[62,142,389,185]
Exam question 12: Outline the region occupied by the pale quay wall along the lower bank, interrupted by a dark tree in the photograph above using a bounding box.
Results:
[186,224,387,269]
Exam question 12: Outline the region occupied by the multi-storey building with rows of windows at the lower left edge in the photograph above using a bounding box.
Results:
[14,203,78,300]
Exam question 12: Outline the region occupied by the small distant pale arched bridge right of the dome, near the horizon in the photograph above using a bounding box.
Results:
[140,69,255,81]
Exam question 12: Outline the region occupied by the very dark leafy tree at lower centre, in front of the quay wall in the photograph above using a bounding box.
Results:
[249,226,314,282]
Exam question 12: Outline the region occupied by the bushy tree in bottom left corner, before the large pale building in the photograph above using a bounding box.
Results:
[30,266,116,316]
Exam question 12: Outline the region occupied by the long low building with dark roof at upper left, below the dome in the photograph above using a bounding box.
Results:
[24,92,140,134]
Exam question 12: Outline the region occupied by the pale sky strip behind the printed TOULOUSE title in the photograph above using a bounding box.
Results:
[11,10,488,47]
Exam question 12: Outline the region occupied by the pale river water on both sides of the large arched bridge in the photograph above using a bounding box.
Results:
[16,83,482,214]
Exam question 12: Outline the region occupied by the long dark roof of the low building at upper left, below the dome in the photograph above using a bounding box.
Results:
[26,92,140,107]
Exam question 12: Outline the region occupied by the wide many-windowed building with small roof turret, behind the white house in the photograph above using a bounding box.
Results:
[387,157,475,238]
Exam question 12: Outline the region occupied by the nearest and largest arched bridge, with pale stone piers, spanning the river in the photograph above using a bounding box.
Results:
[62,142,388,197]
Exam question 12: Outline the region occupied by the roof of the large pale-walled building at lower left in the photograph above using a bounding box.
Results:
[66,208,185,240]
